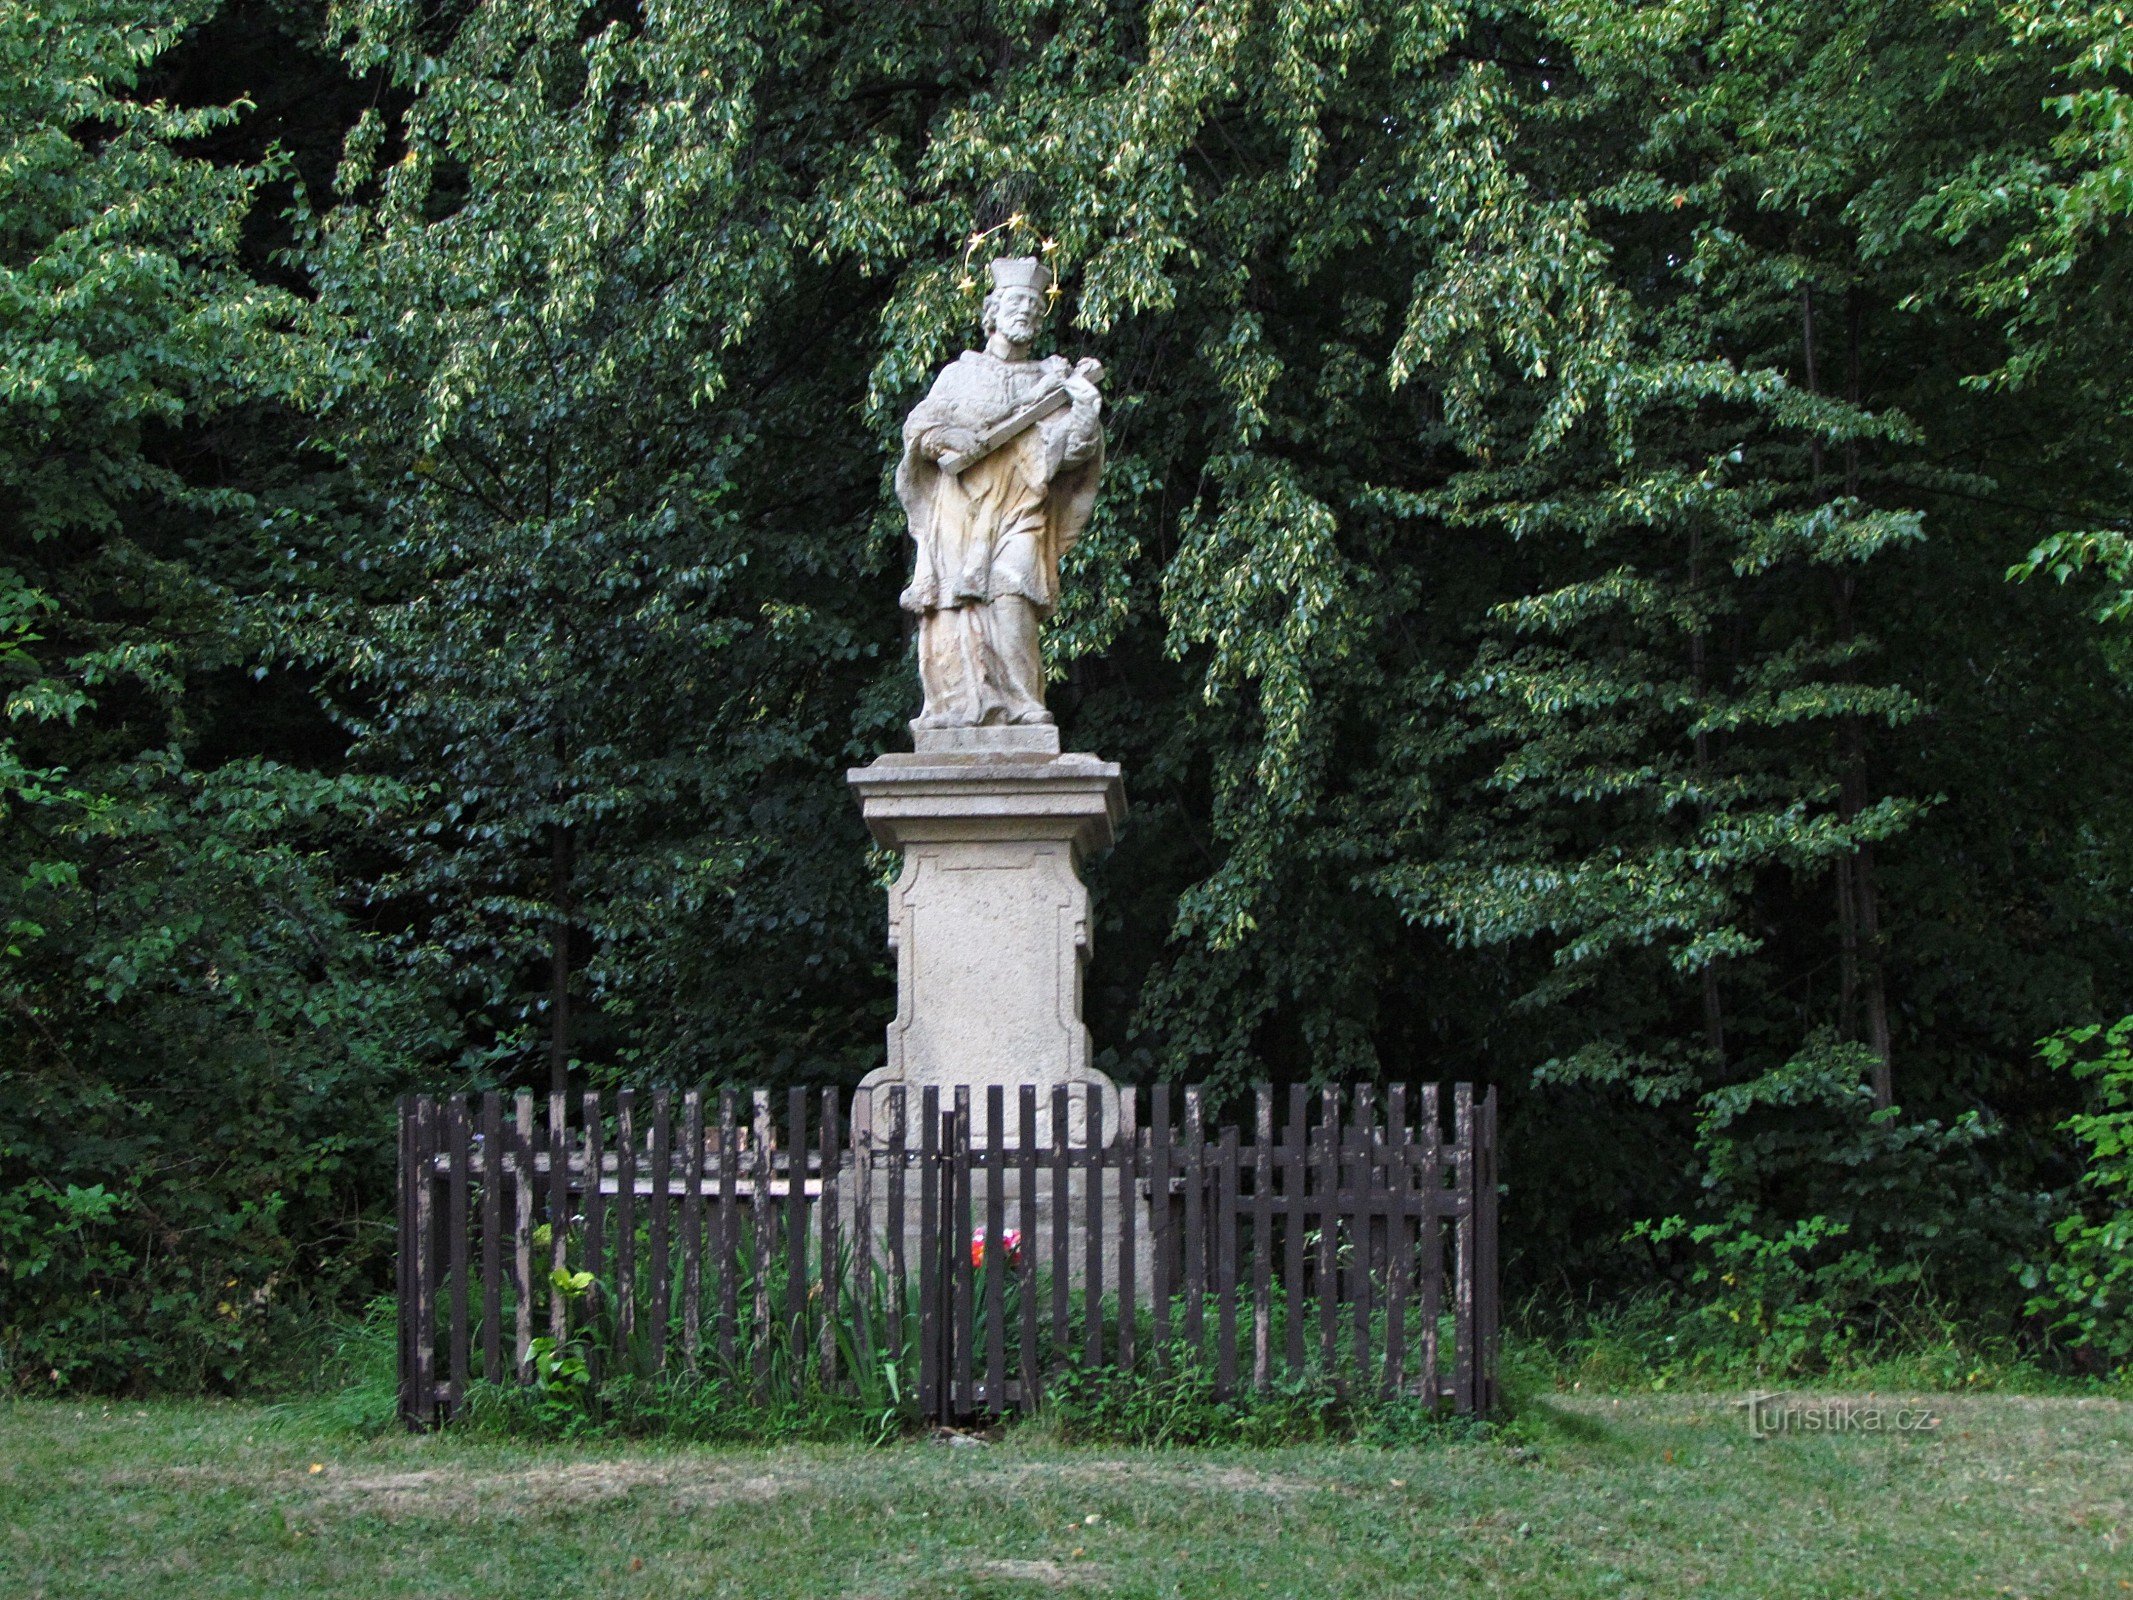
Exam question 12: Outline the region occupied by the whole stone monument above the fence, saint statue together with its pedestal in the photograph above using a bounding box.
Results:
[849,256,1126,1141]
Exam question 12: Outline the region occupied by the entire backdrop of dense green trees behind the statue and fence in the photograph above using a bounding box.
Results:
[0,0,2133,1387]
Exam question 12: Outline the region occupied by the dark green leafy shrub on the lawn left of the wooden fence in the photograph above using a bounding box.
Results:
[0,806,433,1391]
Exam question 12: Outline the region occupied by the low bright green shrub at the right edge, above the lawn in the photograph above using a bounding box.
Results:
[2022,1018,2133,1374]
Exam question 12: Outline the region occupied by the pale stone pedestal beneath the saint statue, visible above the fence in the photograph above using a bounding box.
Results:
[847,727,1126,1143]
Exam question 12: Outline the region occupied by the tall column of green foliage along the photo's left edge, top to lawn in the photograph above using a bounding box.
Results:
[0,0,450,1389]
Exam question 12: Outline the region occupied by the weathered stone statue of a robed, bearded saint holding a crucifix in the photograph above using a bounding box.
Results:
[896,256,1103,727]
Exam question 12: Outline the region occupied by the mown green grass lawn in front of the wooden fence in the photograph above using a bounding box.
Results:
[0,1391,2133,1600]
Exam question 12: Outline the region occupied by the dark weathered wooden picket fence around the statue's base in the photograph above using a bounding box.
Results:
[399,1084,1497,1427]
